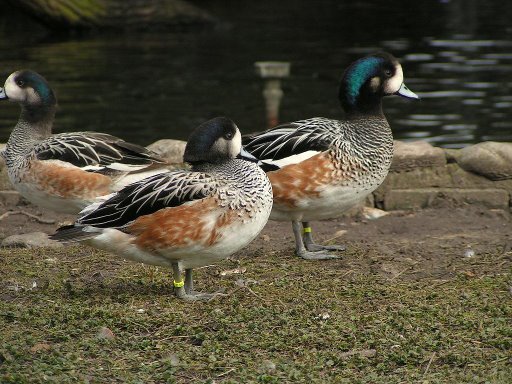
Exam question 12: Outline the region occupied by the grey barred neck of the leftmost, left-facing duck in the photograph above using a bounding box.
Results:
[5,105,56,158]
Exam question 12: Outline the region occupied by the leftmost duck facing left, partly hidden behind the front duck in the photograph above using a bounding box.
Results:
[0,70,169,214]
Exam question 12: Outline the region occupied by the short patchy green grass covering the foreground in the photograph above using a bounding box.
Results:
[0,247,512,383]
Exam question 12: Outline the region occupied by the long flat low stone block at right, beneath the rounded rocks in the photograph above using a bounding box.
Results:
[384,188,510,211]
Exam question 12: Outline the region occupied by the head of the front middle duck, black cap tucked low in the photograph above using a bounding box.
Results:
[183,117,258,164]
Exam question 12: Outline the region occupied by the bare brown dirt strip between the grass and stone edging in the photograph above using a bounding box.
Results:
[0,203,512,280]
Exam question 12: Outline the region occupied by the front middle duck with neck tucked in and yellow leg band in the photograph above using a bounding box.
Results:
[51,117,272,301]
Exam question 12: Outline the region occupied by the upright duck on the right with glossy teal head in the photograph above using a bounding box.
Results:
[243,52,419,260]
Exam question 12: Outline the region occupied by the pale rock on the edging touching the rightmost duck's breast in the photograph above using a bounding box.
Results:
[390,141,446,171]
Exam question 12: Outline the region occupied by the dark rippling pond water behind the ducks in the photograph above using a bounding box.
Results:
[0,0,512,147]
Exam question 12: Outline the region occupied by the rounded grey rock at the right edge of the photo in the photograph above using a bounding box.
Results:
[455,141,512,180]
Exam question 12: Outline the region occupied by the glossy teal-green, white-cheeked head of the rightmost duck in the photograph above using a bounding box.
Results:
[339,52,419,116]
